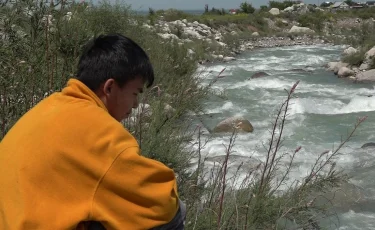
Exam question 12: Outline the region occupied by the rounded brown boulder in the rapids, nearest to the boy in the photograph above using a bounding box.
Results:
[213,117,254,133]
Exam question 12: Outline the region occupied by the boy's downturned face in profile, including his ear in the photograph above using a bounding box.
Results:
[103,77,144,121]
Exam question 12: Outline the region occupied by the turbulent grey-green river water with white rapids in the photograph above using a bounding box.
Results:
[195,45,375,229]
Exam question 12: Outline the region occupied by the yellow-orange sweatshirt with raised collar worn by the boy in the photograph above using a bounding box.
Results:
[0,79,179,230]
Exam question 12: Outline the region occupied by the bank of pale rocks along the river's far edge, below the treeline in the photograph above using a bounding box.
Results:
[143,19,330,64]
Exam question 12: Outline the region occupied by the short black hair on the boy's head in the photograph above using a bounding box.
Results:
[77,34,154,91]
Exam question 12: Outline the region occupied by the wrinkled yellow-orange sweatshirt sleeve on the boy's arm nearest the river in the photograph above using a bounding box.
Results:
[90,147,179,230]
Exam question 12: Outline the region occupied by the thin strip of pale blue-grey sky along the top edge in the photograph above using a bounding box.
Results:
[106,0,332,11]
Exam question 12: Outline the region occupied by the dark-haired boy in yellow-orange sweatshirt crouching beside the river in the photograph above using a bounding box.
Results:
[0,34,185,230]
